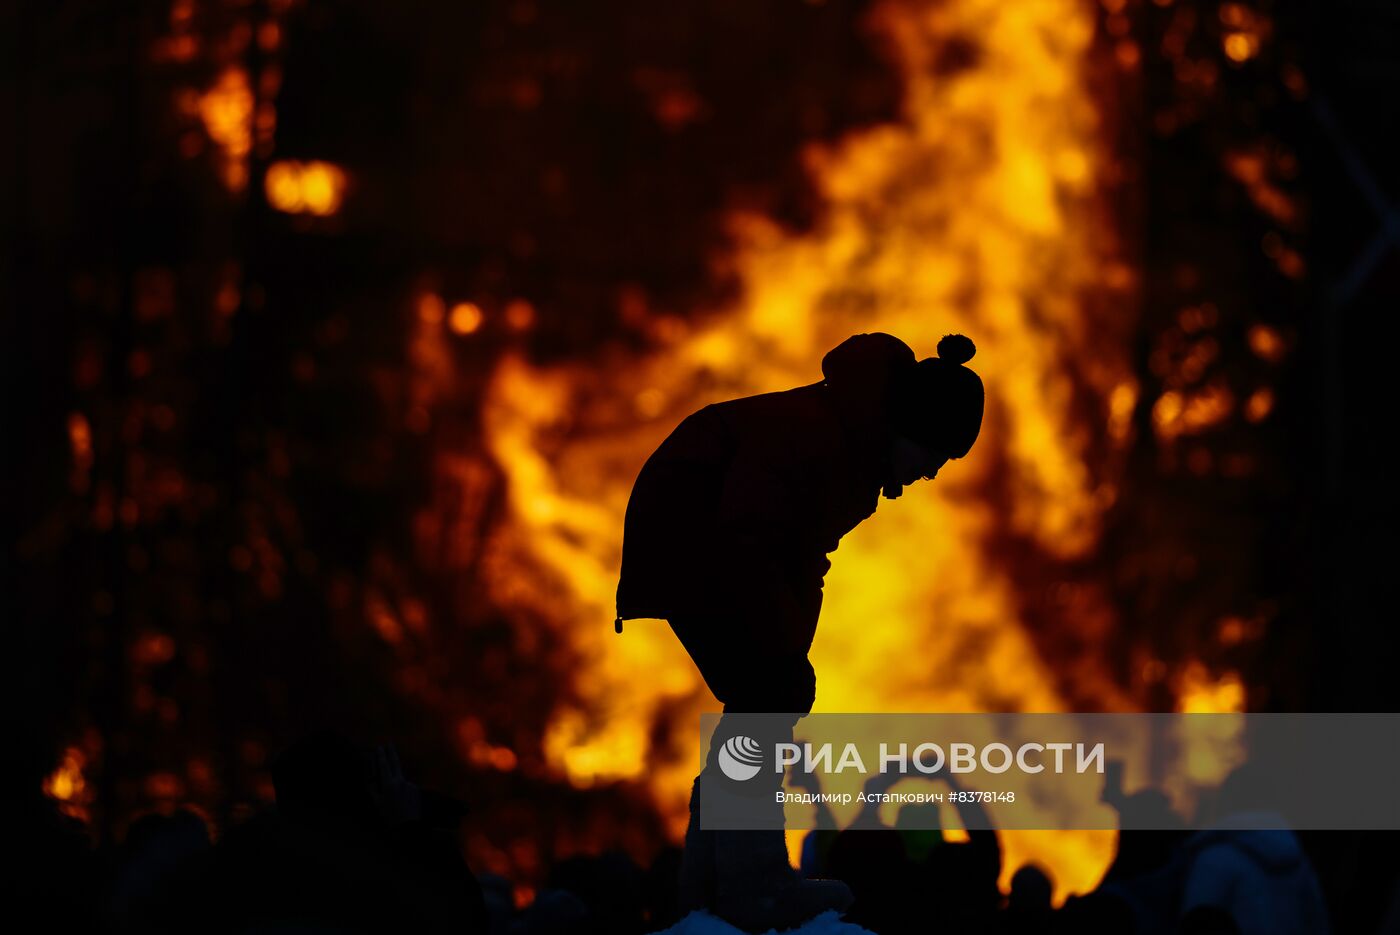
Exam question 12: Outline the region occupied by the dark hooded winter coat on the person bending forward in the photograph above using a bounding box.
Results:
[617,335,914,654]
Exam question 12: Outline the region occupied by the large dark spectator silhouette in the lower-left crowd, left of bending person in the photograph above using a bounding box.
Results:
[210,731,487,934]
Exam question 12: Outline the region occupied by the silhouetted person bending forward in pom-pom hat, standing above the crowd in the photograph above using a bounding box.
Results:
[617,333,983,931]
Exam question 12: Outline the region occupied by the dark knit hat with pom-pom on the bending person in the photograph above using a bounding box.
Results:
[895,335,984,458]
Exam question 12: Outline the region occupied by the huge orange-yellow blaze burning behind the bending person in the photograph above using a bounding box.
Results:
[464,0,1137,893]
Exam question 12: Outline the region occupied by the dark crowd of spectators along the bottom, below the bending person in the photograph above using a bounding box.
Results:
[7,732,1400,935]
